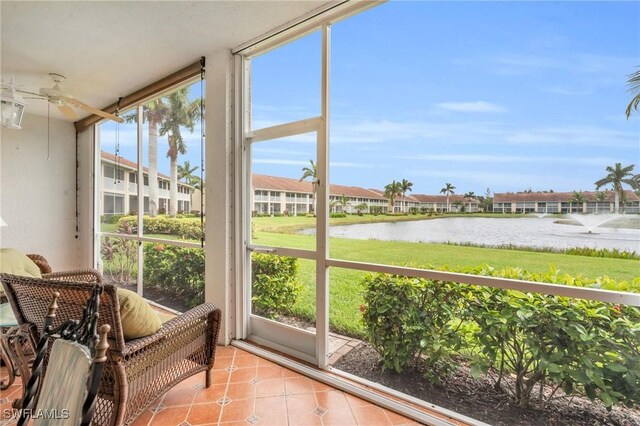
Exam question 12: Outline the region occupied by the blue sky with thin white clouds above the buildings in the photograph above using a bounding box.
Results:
[102,1,640,194]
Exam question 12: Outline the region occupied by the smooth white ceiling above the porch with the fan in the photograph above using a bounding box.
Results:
[5,0,328,119]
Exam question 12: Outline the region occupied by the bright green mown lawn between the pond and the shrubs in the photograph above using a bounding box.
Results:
[254,230,640,336]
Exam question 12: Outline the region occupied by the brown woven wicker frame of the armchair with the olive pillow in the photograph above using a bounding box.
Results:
[0,274,221,425]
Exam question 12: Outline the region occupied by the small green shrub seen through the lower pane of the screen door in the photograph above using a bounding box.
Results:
[251,253,302,318]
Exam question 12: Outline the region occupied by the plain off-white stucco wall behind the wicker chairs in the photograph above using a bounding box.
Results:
[0,114,80,270]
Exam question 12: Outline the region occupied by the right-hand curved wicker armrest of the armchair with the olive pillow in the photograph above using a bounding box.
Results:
[120,303,221,358]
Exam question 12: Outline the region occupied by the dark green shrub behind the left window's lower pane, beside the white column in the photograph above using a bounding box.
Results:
[143,243,204,307]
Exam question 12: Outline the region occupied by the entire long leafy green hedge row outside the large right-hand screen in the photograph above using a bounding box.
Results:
[361,266,640,408]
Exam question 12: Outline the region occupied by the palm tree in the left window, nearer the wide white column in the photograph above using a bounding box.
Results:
[159,87,200,217]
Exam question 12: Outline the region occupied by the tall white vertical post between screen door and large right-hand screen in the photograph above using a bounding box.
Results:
[316,24,331,369]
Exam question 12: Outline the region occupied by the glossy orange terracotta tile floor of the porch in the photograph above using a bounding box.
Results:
[0,346,419,426]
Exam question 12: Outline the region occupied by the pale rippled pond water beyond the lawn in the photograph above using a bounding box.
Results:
[301,216,640,253]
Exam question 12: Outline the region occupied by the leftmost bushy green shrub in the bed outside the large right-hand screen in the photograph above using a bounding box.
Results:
[361,274,461,381]
